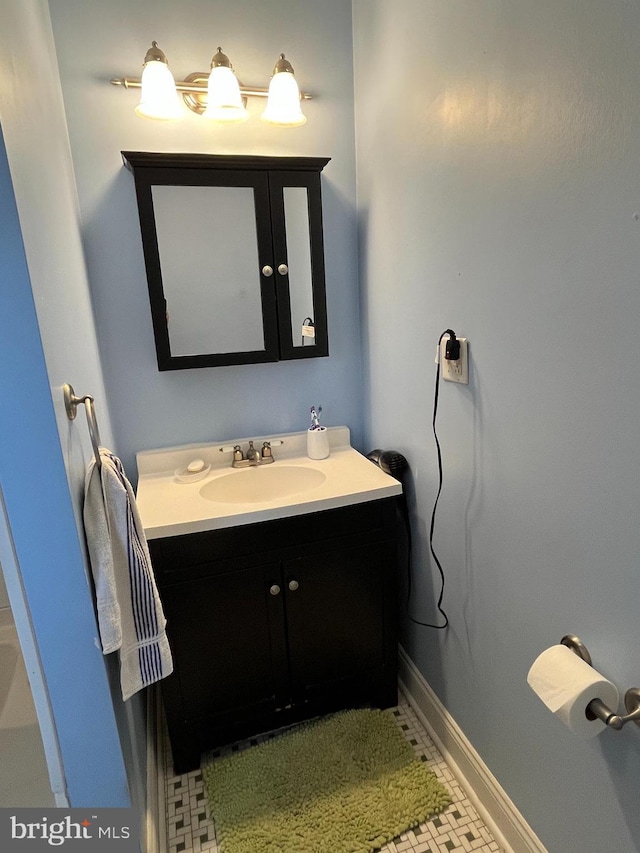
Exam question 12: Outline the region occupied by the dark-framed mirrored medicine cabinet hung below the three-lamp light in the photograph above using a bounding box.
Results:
[122,151,329,370]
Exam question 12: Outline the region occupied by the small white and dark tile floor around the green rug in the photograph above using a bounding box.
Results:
[160,694,501,853]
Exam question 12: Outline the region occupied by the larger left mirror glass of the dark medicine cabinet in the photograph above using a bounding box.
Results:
[151,186,268,356]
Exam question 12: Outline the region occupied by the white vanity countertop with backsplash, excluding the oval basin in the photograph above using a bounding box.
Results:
[136,427,402,539]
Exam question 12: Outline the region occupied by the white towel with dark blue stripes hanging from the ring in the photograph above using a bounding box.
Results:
[84,447,173,700]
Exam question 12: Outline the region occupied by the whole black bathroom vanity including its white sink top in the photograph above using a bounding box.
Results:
[138,428,401,772]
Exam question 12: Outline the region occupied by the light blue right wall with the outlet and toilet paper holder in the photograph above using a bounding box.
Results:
[354,0,640,853]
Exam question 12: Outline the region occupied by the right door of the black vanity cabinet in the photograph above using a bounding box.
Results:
[284,542,397,704]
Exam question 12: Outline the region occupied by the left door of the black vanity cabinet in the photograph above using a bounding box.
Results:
[161,564,288,725]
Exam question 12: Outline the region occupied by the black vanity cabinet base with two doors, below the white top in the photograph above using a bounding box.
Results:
[149,498,397,773]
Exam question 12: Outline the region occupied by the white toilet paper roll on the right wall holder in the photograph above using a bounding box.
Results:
[527,645,618,738]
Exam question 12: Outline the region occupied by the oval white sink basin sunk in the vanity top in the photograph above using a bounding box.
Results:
[200,465,327,504]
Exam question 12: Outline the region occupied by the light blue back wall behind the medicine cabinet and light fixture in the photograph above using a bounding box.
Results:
[50,0,362,475]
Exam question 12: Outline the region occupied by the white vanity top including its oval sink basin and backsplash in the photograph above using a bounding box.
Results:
[136,427,402,539]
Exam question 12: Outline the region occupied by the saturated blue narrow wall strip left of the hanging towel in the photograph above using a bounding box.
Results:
[0,125,130,806]
